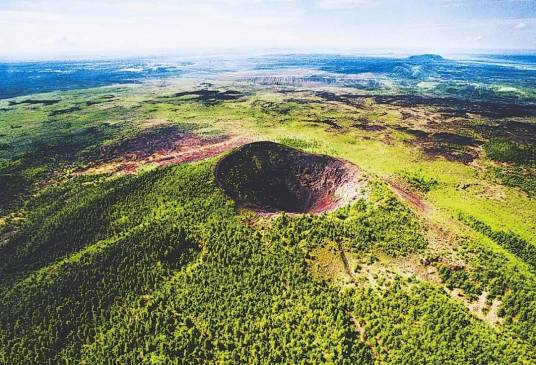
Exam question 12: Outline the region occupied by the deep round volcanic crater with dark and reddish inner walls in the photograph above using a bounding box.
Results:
[215,142,360,213]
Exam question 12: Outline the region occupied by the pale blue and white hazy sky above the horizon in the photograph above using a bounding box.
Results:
[0,0,536,59]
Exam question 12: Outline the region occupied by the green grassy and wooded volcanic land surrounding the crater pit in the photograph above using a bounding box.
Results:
[0,80,536,364]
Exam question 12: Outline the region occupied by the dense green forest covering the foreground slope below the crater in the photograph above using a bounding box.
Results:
[0,160,536,365]
